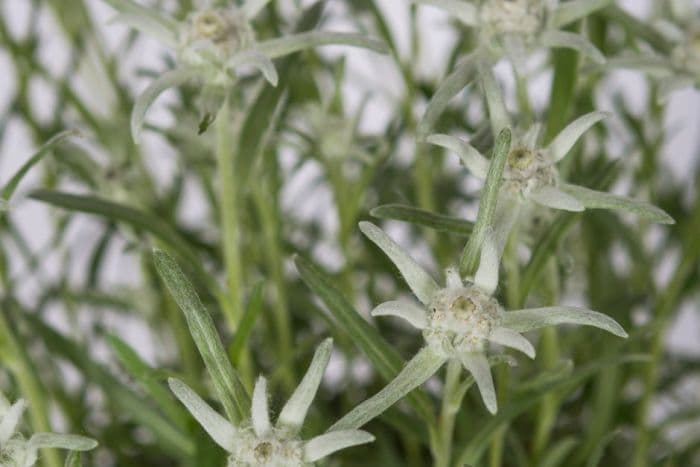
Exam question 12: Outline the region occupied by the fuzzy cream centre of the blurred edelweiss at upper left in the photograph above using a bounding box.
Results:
[180,8,255,66]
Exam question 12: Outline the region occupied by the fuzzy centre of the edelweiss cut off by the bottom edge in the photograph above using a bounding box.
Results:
[228,430,304,467]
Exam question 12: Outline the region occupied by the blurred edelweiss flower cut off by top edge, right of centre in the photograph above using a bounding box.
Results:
[412,0,611,69]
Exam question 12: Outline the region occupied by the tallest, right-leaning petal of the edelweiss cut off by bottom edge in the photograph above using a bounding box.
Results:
[277,339,333,434]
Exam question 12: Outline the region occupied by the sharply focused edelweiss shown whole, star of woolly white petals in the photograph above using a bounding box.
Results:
[333,222,627,416]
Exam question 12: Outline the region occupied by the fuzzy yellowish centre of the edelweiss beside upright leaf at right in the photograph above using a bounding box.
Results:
[503,146,558,196]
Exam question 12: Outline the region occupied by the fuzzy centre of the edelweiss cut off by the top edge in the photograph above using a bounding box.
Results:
[481,0,544,35]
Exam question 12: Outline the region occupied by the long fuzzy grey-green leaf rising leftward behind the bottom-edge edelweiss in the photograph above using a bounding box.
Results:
[153,250,250,424]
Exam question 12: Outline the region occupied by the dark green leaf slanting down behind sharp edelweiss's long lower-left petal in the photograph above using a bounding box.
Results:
[294,256,433,420]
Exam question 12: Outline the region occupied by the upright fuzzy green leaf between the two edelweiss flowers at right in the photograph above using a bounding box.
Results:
[460,128,511,275]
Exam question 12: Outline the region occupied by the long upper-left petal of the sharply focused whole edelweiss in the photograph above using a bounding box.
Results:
[360,222,440,305]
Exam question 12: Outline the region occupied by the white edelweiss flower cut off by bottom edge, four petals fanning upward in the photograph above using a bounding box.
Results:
[168,339,374,467]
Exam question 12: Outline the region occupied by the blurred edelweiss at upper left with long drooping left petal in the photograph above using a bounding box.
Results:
[106,0,386,140]
